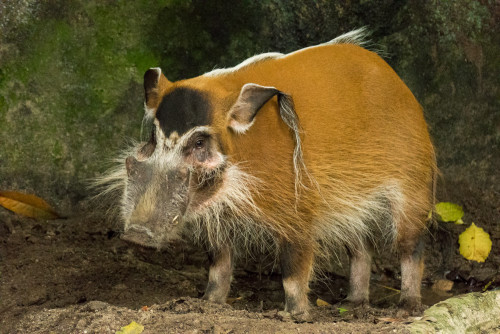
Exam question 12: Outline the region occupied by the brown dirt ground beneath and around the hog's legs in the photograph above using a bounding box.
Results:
[0,181,500,334]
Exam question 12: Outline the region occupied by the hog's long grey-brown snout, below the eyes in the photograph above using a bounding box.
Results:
[121,151,190,249]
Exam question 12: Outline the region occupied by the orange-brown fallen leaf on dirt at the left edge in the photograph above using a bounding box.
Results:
[0,191,59,219]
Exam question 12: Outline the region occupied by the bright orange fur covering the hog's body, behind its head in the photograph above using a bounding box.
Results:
[174,44,435,250]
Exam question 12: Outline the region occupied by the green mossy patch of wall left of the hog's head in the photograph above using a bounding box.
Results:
[0,1,162,209]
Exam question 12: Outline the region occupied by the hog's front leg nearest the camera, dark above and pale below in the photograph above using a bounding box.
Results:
[281,242,314,321]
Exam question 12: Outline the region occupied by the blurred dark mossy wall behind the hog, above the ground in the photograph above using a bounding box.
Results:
[0,0,500,210]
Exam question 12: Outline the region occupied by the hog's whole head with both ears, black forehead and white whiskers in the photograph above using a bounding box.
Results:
[121,69,293,249]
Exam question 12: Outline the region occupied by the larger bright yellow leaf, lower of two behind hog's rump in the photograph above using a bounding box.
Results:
[458,223,491,262]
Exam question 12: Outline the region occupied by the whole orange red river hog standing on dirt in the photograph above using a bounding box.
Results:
[97,29,437,320]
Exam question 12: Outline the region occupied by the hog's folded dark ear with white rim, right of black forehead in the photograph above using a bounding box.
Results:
[228,83,280,133]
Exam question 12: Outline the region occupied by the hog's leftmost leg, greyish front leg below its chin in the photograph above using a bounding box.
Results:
[203,246,233,304]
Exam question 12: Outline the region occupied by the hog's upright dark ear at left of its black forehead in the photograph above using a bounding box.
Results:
[144,67,172,118]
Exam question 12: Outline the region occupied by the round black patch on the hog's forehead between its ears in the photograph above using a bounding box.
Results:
[156,87,211,137]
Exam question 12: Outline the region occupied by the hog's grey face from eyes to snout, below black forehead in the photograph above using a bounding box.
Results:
[121,122,225,249]
